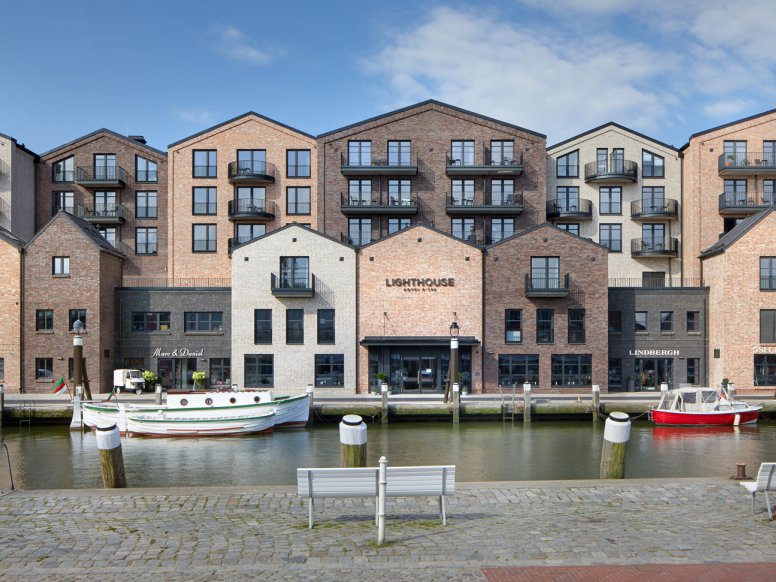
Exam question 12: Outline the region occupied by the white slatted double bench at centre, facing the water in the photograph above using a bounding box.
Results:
[296,465,455,528]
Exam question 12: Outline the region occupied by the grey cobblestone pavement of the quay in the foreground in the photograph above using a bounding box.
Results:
[0,479,776,582]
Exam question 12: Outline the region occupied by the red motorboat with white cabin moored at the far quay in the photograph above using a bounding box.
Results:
[649,388,762,426]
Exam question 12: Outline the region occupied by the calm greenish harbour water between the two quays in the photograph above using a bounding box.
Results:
[0,422,776,491]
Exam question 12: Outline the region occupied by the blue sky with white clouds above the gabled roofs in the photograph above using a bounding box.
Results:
[0,0,776,152]
